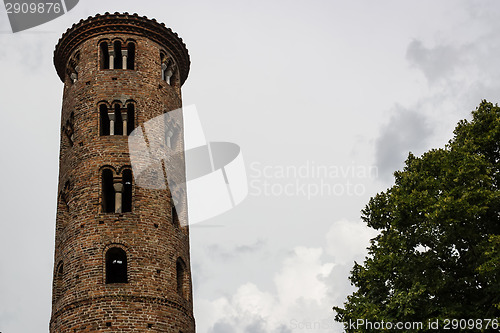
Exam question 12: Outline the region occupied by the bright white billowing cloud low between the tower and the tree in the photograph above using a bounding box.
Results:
[195,220,375,333]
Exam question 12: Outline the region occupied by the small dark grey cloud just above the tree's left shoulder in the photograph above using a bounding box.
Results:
[375,106,434,181]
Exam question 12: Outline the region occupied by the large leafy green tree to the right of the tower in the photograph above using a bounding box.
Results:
[333,101,500,332]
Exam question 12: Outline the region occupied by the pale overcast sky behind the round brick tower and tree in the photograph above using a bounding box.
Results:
[0,0,500,333]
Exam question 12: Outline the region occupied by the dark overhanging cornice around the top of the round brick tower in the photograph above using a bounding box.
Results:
[54,13,190,84]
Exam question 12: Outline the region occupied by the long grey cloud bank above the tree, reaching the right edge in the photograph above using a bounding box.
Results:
[375,22,500,181]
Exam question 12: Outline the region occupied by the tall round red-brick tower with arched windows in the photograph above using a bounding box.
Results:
[50,13,195,333]
